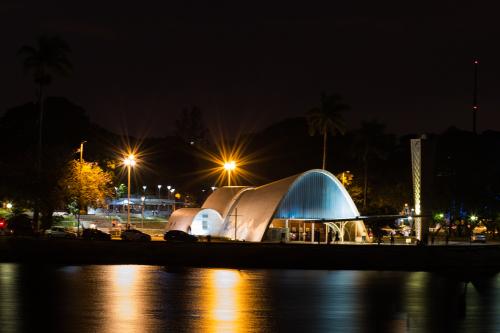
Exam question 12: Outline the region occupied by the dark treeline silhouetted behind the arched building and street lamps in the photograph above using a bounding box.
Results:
[0,97,500,219]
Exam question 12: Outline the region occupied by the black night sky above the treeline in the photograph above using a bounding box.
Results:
[0,0,500,136]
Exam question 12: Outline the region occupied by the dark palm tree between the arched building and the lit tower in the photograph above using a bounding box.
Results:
[353,120,392,210]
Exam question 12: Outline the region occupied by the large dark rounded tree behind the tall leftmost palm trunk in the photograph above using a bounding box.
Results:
[0,97,89,228]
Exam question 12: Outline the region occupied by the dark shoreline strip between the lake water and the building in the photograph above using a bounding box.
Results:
[0,238,500,275]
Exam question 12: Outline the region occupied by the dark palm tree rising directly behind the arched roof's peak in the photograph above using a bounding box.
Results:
[306,93,350,169]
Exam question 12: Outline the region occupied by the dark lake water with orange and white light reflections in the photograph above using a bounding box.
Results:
[0,264,500,333]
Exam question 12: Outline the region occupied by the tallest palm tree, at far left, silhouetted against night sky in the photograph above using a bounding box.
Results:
[17,35,72,229]
